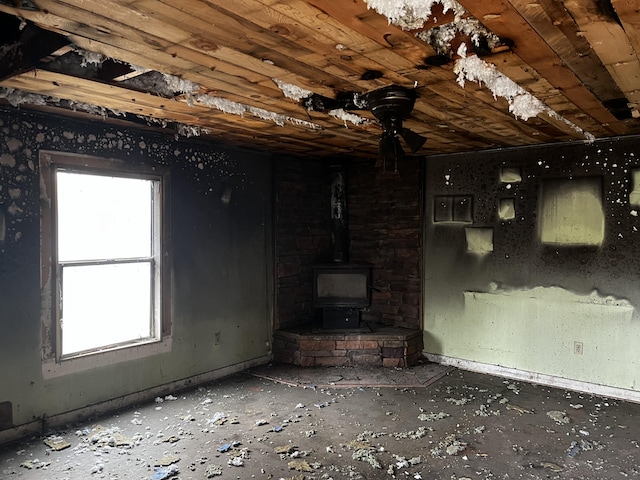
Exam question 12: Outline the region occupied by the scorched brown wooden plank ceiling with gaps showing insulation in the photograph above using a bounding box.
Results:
[0,0,640,158]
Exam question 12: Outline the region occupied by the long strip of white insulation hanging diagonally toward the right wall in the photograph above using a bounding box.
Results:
[453,44,595,142]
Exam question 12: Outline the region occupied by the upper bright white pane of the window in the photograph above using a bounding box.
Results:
[56,171,153,261]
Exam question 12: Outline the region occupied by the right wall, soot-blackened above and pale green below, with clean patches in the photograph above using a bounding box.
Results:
[424,137,640,396]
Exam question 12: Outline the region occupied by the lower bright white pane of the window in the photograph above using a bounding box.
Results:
[62,262,154,355]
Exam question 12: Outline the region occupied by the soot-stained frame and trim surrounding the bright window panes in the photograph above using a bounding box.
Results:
[39,151,171,377]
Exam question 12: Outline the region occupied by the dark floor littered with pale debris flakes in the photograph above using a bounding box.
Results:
[0,363,640,480]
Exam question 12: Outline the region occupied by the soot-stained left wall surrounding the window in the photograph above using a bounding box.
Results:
[0,107,273,439]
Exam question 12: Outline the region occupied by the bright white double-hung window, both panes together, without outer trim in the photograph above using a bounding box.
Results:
[55,168,161,357]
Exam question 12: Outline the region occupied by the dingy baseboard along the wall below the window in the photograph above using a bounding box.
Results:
[0,355,273,445]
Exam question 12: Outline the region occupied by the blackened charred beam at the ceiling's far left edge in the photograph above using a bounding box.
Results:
[0,14,70,81]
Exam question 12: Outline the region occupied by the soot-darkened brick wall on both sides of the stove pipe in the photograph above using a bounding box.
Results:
[275,159,423,328]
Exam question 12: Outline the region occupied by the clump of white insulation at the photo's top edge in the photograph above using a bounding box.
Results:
[365,0,466,30]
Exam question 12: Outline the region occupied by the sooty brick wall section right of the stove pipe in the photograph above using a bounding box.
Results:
[348,158,424,328]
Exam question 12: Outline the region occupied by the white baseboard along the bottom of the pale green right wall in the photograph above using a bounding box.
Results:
[423,352,640,403]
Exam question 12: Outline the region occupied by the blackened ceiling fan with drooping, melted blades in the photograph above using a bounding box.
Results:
[302,84,427,169]
